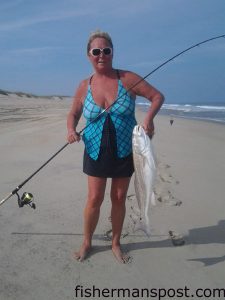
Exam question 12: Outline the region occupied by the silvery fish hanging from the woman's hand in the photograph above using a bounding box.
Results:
[131,125,157,237]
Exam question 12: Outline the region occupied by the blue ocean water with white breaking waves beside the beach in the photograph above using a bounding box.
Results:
[137,99,225,125]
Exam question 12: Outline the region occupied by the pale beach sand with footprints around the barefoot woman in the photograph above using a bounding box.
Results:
[0,95,225,300]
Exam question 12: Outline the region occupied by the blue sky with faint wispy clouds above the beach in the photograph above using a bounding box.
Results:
[0,0,225,104]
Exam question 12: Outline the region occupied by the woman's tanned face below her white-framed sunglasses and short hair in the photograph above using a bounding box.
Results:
[88,38,113,72]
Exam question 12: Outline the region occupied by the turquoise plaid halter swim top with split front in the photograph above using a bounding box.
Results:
[83,72,137,160]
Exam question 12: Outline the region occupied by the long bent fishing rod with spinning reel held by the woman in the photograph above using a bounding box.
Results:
[0,34,225,209]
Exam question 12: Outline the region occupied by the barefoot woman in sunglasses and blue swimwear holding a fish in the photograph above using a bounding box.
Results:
[67,31,164,263]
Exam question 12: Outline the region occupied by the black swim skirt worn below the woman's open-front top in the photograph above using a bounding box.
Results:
[83,114,134,178]
